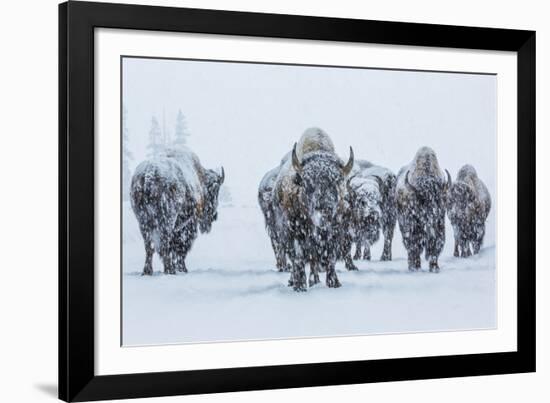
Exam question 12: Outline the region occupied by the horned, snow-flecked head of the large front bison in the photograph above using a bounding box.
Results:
[292,144,353,231]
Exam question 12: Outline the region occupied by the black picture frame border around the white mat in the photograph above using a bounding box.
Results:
[59,1,535,401]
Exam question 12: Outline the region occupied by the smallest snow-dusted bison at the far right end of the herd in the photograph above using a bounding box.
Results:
[447,165,491,257]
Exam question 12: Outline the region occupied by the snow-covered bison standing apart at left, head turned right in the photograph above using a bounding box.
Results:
[130,149,225,275]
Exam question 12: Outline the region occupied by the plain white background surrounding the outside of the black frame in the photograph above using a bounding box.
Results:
[0,0,550,403]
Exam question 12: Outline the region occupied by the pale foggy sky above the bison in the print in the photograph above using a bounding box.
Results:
[123,58,496,207]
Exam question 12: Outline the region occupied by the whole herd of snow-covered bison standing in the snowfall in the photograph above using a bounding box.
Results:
[130,128,491,291]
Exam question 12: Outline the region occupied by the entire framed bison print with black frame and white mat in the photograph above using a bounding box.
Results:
[59,2,535,401]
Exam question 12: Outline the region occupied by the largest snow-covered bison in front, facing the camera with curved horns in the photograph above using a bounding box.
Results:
[272,128,353,291]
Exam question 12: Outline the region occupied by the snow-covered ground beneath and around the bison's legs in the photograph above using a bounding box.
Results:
[122,203,496,345]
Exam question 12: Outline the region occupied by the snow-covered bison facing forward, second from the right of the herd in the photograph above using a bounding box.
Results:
[396,147,452,272]
